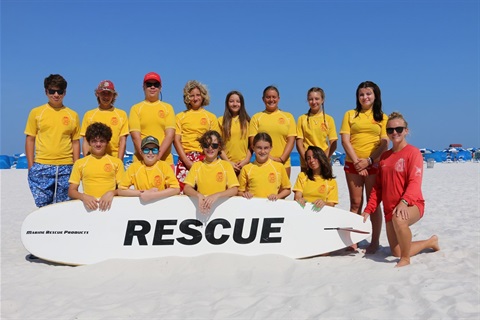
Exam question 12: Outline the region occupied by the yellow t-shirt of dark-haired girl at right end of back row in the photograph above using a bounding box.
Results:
[340,109,388,161]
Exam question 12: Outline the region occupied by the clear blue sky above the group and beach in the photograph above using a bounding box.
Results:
[0,0,480,154]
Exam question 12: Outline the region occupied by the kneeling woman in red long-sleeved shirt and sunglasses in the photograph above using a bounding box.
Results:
[362,112,440,267]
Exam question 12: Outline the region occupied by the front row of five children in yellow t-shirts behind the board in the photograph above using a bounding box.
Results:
[68,122,338,213]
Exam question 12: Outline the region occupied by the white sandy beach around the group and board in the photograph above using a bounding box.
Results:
[0,163,480,319]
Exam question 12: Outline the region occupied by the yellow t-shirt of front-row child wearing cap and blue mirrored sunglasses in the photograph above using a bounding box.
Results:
[118,160,180,190]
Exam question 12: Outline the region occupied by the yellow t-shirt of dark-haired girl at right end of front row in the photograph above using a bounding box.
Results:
[293,172,338,203]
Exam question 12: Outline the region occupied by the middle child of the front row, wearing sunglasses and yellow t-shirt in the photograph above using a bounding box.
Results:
[183,130,239,214]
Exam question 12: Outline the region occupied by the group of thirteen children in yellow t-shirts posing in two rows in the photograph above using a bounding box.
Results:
[25,72,438,266]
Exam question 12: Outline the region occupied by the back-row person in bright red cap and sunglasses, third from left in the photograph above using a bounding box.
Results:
[128,72,175,168]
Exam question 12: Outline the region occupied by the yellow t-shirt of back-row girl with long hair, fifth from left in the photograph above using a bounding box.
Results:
[218,116,249,162]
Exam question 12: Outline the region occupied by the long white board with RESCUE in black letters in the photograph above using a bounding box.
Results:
[21,196,371,265]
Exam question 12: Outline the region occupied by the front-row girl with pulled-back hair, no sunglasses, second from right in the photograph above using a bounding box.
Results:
[238,132,292,201]
